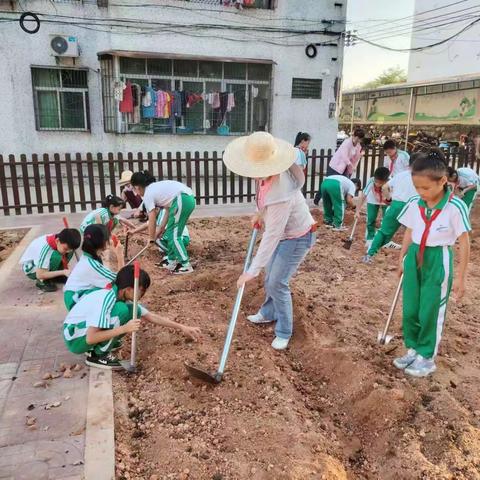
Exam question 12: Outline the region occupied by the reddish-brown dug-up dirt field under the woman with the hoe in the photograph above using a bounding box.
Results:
[114,205,480,480]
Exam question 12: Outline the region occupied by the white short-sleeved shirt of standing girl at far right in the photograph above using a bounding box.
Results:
[398,196,471,247]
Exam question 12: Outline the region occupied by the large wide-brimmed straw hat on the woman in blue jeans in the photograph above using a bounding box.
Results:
[223,132,295,178]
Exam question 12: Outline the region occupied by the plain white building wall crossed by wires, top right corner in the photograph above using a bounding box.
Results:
[408,0,480,82]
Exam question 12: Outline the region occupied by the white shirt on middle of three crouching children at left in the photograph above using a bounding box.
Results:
[63,253,117,292]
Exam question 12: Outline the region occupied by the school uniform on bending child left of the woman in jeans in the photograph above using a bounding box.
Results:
[143,180,195,265]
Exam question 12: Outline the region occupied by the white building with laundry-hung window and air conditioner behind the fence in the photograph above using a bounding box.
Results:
[0,0,346,154]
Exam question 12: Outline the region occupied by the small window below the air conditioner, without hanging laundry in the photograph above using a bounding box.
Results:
[32,67,90,131]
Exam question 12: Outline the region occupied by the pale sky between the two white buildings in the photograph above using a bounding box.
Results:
[343,0,415,89]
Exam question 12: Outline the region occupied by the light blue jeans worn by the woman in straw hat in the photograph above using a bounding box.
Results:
[260,232,316,339]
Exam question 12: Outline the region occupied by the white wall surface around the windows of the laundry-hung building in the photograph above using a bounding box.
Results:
[0,0,346,154]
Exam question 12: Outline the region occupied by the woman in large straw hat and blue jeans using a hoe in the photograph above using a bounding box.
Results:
[223,132,315,350]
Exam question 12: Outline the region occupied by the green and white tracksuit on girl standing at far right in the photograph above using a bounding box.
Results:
[398,192,471,359]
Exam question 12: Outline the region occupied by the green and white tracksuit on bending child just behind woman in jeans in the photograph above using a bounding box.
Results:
[320,175,356,227]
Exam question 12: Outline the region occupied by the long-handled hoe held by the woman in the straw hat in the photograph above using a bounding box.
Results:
[185,225,260,384]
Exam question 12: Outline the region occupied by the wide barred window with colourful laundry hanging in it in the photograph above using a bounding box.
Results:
[100,56,272,135]
